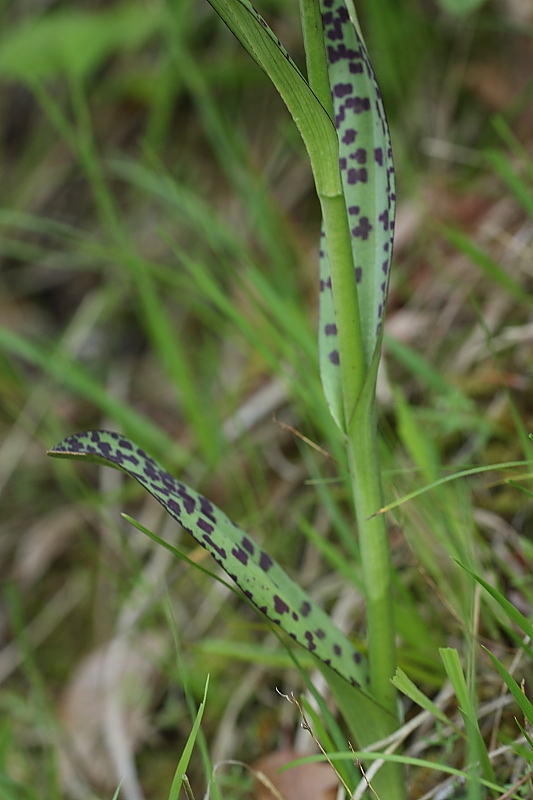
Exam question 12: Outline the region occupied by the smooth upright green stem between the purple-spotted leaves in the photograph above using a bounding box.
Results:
[300,0,405,800]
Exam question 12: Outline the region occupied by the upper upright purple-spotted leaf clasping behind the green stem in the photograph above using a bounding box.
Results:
[319,0,395,427]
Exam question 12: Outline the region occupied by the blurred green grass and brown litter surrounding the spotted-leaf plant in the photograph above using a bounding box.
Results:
[0,0,533,799]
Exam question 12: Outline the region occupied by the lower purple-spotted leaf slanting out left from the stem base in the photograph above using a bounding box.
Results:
[48,431,365,686]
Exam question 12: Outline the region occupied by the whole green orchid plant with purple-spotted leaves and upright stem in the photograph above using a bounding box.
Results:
[49,0,404,800]
